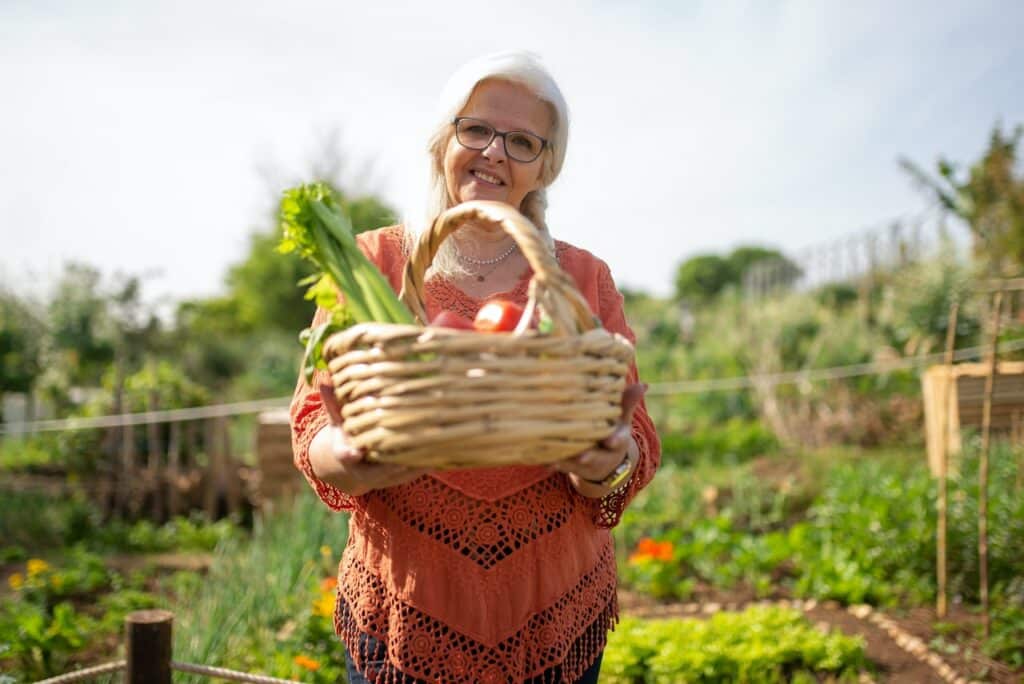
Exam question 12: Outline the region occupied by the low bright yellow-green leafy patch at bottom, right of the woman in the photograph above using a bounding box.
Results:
[601,607,867,684]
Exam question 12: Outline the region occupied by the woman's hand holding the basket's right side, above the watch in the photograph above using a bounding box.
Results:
[550,383,647,498]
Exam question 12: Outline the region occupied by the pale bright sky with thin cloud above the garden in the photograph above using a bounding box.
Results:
[0,0,1024,301]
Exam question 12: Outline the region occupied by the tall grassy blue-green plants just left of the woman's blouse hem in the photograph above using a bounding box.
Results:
[174,491,348,682]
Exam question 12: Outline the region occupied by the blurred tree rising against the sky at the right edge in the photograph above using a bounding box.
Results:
[900,124,1024,275]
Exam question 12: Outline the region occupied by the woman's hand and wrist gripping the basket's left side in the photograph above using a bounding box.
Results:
[309,385,430,497]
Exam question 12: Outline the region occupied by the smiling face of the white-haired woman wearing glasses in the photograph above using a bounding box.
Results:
[443,81,551,209]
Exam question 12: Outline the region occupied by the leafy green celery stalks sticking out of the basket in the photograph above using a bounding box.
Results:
[278,182,416,381]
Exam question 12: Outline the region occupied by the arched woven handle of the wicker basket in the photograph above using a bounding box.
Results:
[398,200,600,336]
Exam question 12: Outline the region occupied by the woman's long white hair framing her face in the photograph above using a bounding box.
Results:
[406,50,569,275]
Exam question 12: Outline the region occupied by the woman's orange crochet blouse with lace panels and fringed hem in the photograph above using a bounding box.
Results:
[291,227,659,683]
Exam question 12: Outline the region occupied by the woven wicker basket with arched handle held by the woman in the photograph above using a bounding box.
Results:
[325,202,634,469]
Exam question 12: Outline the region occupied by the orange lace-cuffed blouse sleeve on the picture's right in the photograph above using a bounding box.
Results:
[581,262,662,527]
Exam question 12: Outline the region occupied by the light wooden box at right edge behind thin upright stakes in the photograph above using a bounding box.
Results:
[922,361,1024,475]
